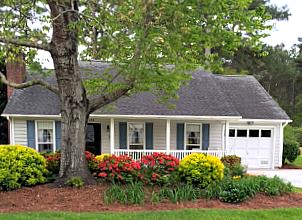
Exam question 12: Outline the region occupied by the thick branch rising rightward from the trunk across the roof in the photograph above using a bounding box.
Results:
[88,81,134,114]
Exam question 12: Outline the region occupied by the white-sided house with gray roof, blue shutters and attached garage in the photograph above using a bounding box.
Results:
[2,62,291,169]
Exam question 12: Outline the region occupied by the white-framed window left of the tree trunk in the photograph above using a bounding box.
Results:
[37,121,54,152]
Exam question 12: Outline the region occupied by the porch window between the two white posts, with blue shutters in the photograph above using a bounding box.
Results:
[128,122,145,150]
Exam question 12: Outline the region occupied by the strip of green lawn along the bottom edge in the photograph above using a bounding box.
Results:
[0,208,302,220]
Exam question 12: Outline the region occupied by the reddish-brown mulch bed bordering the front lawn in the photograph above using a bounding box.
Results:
[0,184,302,213]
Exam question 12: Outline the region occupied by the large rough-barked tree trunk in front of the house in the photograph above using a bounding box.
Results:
[49,0,93,183]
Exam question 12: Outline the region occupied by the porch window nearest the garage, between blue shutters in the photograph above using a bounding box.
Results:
[186,124,201,150]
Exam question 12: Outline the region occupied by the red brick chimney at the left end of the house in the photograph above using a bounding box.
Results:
[6,55,26,99]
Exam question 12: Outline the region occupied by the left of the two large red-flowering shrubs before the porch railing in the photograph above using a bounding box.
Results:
[97,155,141,183]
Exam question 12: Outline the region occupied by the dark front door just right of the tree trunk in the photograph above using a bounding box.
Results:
[86,123,102,155]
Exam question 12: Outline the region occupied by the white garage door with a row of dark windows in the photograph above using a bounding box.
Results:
[227,127,274,168]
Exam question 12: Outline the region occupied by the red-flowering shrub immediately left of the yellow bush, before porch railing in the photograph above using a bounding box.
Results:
[139,153,179,184]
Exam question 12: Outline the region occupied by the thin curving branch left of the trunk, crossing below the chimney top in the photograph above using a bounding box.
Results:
[0,72,59,95]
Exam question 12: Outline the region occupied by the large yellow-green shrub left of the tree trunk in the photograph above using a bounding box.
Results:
[0,145,47,191]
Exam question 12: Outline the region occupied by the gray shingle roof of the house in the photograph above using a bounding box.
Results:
[3,62,289,120]
